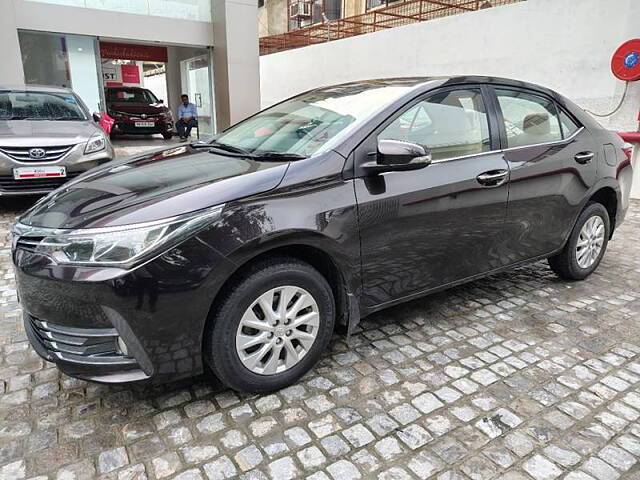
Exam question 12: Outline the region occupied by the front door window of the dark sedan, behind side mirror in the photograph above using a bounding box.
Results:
[378,90,491,160]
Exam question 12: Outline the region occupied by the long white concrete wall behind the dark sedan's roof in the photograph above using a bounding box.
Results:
[260,0,640,130]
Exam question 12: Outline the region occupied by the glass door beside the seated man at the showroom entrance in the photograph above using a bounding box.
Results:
[180,55,216,137]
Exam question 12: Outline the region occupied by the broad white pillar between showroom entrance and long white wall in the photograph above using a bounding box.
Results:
[211,0,260,131]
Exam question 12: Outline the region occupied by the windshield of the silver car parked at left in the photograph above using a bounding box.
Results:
[0,90,87,121]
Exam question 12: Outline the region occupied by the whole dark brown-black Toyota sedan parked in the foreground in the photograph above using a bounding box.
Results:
[13,77,632,392]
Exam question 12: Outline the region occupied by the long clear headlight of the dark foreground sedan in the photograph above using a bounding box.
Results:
[14,205,224,267]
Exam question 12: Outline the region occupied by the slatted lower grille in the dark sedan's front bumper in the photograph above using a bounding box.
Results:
[29,316,122,358]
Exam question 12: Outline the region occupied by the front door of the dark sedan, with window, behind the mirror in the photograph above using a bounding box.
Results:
[355,87,509,306]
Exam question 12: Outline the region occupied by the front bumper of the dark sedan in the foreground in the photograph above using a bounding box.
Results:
[13,232,234,383]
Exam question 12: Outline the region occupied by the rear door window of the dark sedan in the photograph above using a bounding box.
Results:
[496,90,562,148]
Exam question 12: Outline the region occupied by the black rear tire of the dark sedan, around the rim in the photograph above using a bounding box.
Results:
[549,202,611,280]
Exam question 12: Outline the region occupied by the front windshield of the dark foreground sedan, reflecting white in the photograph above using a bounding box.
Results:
[215,82,415,156]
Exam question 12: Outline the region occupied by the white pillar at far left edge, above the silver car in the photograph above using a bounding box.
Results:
[0,0,24,85]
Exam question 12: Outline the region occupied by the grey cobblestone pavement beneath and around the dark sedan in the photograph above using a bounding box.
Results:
[0,197,640,480]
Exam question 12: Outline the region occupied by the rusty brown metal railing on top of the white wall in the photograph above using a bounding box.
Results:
[260,0,523,55]
